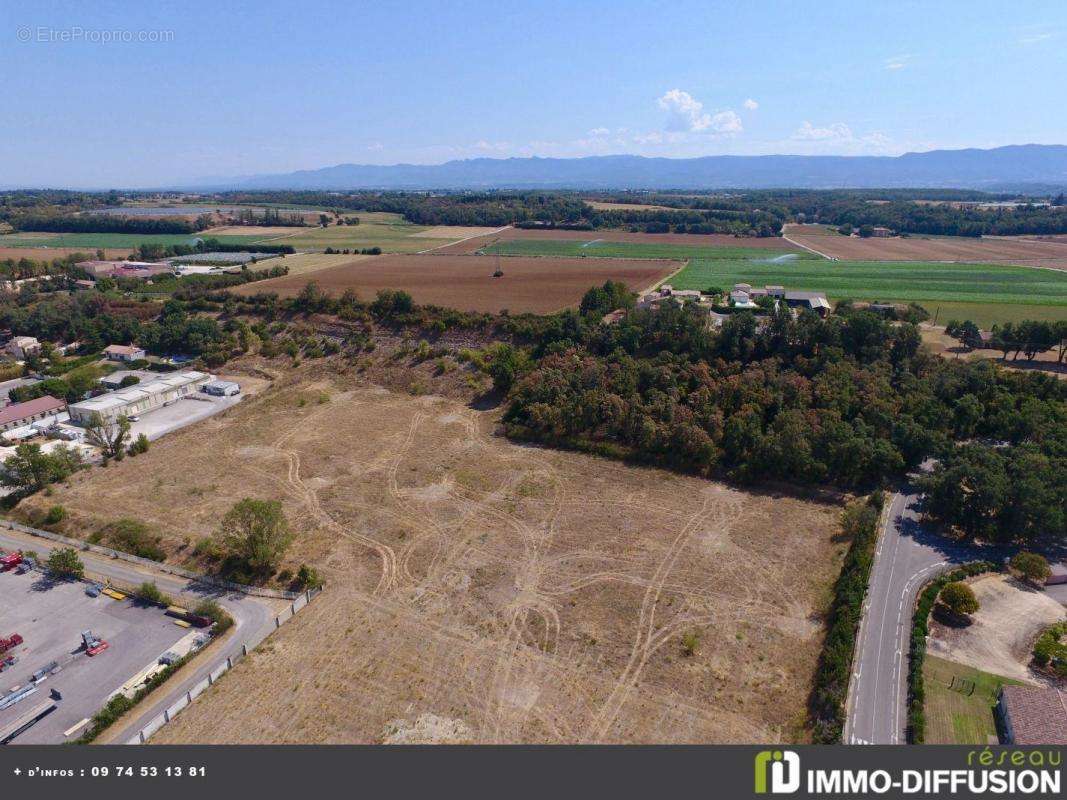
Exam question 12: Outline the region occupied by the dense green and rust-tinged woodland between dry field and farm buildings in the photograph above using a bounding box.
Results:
[505,306,1067,550]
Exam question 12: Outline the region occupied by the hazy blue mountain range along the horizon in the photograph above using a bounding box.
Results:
[194,144,1067,193]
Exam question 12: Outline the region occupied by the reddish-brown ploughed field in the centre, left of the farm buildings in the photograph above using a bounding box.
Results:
[234,255,678,314]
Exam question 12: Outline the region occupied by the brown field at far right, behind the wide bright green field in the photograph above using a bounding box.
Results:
[786,225,1067,270]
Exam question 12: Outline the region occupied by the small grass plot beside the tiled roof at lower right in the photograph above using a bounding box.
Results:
[923,655,1022,745]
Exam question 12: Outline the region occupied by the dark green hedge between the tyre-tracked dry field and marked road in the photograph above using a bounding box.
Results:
[809,492,886,745]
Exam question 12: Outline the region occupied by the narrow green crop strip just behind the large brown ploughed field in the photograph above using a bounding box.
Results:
[479,239,819,263]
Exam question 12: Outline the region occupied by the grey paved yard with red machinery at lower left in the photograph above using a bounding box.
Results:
[0,572,190,745]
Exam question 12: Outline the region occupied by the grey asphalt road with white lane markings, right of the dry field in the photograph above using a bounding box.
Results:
[844,485,1003,745]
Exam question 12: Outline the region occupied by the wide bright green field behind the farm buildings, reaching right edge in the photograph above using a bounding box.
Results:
[670,259,1067,324]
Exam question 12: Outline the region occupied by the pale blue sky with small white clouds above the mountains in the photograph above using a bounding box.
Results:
[0,0,1067,187]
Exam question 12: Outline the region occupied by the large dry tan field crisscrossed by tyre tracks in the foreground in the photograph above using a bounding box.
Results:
[22,363,845,743]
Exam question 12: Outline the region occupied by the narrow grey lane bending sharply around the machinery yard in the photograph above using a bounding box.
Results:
[0,528,285,741]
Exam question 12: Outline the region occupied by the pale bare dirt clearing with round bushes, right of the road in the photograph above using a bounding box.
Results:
[928,575,1065,682]
